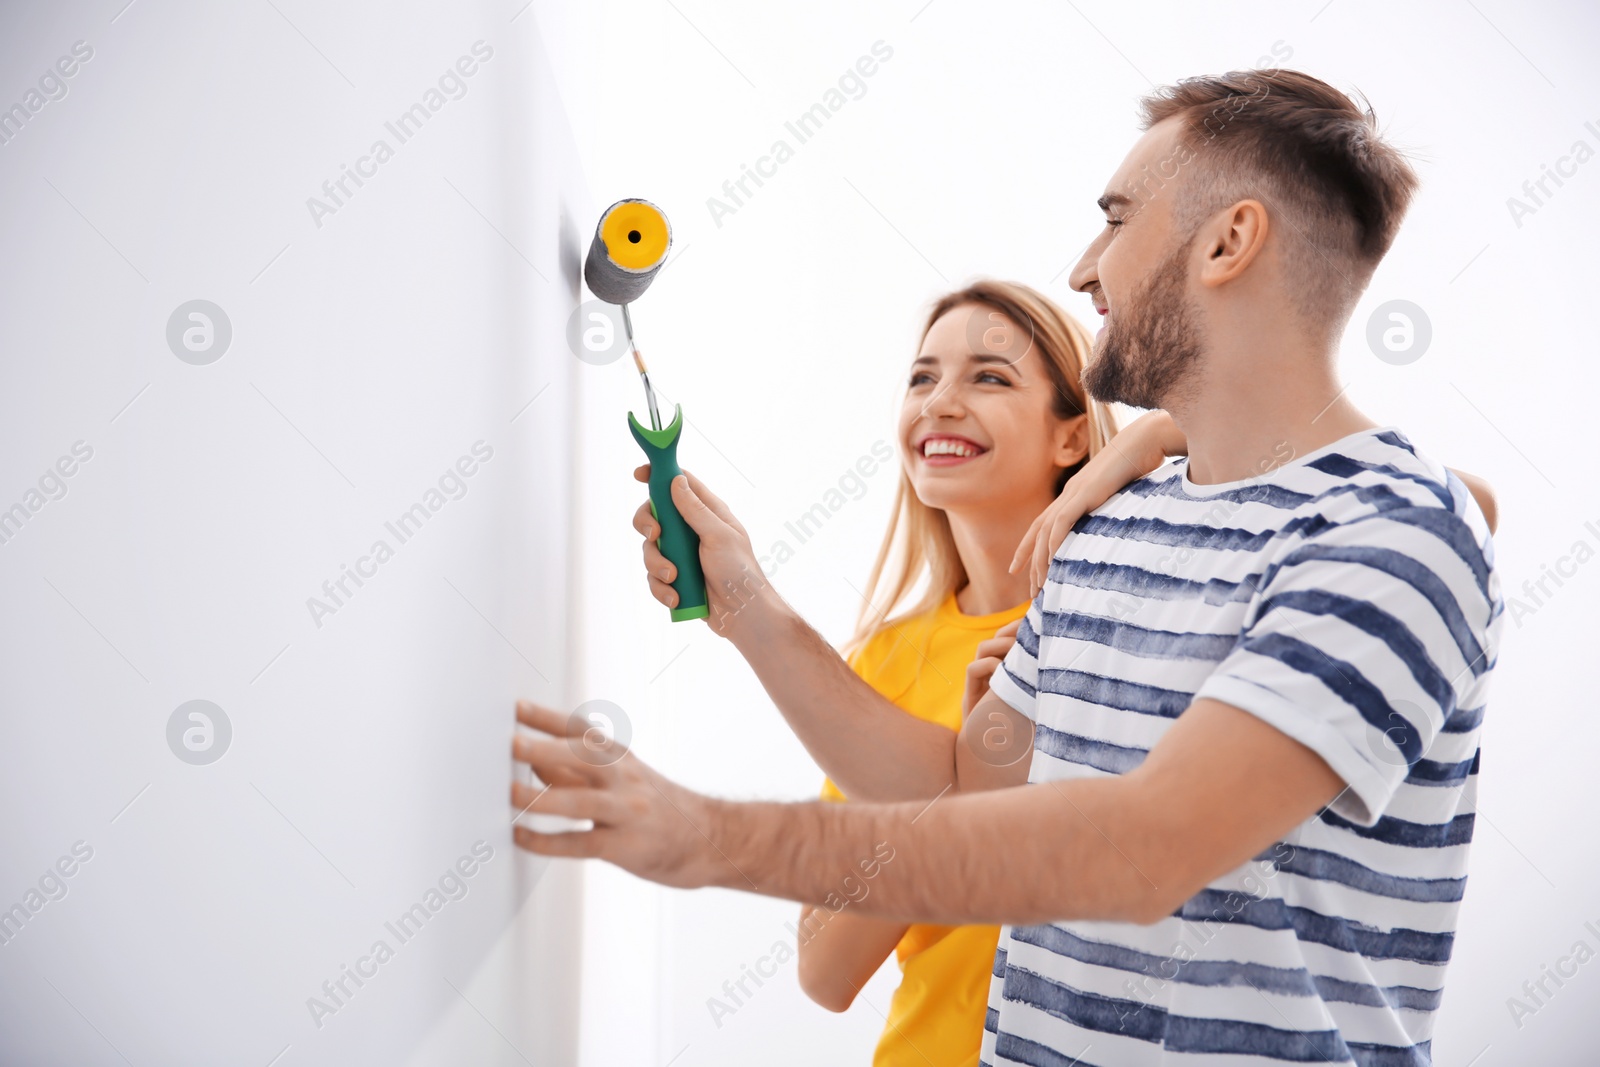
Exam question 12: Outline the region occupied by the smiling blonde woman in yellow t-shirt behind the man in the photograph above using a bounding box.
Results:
[798,282,1114,1067]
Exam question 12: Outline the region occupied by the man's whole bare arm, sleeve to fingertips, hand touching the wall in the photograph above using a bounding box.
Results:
[512,701,1344,925]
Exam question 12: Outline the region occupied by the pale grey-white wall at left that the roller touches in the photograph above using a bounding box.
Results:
[0,0,594,1065]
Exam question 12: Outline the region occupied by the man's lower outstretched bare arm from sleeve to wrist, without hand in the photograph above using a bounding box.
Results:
[710,701,1344,923]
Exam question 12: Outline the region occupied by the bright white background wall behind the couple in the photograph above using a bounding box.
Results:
[578,0,1600,1067]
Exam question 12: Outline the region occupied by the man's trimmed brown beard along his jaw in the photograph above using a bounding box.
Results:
[1083,242,1200,408]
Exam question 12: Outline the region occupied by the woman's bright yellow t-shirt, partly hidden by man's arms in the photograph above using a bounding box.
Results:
[822,593,1027,1067]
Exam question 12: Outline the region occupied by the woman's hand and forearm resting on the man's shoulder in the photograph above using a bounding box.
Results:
[1011,411,1189,593]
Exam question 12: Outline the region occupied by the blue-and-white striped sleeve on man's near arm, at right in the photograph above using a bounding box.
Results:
[1195,506,1501,825]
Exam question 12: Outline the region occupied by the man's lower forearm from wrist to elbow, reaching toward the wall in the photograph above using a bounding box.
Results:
[709,779,1166,925]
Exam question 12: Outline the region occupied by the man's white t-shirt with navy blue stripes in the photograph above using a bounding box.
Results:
[982,429,1504,1067]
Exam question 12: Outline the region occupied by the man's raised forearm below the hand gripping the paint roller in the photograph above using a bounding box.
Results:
[730,603,955,801]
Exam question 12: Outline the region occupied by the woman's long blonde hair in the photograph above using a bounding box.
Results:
[845,278,1117,651]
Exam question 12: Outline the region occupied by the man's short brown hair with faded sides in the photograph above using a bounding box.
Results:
[1139,70,1418,326]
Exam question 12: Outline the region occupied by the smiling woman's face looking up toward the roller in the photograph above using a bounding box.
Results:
[899,304,1088,512]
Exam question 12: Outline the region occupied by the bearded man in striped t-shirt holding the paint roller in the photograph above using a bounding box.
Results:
[512,70,1502,1065]
